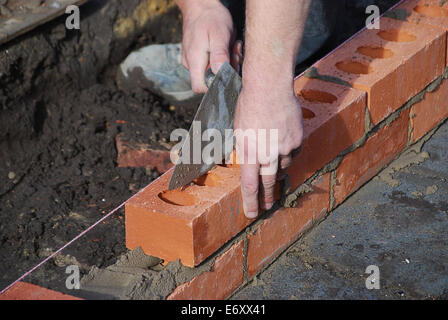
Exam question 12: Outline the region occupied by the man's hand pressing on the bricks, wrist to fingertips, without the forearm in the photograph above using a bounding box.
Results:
[235,84,303,219]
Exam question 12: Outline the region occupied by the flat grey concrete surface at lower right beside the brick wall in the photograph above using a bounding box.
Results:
[232,122,448,299]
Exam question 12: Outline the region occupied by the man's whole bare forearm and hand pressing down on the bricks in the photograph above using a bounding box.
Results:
[235,0,310,219]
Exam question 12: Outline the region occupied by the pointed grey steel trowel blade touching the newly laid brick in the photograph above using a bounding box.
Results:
[168,63,241,190]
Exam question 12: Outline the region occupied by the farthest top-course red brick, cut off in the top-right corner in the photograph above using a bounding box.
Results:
[395,0,448,66]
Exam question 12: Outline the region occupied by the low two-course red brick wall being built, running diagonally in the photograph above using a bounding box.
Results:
[126,0,448,299]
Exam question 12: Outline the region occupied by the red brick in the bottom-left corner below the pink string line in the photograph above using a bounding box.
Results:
[0,282,82,300]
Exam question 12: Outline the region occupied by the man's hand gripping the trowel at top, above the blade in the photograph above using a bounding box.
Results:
[177,0,242,93]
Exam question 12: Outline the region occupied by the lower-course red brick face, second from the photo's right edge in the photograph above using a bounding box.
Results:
[334,109,409,204]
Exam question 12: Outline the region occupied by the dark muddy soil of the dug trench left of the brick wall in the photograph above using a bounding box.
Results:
[0,0,397,297]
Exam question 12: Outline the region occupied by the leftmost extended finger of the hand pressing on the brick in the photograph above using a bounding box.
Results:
[241,164,260,219]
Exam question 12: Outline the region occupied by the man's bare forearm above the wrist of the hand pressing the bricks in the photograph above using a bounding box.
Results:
[243,0,311,88]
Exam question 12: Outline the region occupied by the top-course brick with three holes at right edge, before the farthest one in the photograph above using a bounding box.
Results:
[315,18,447,125]
